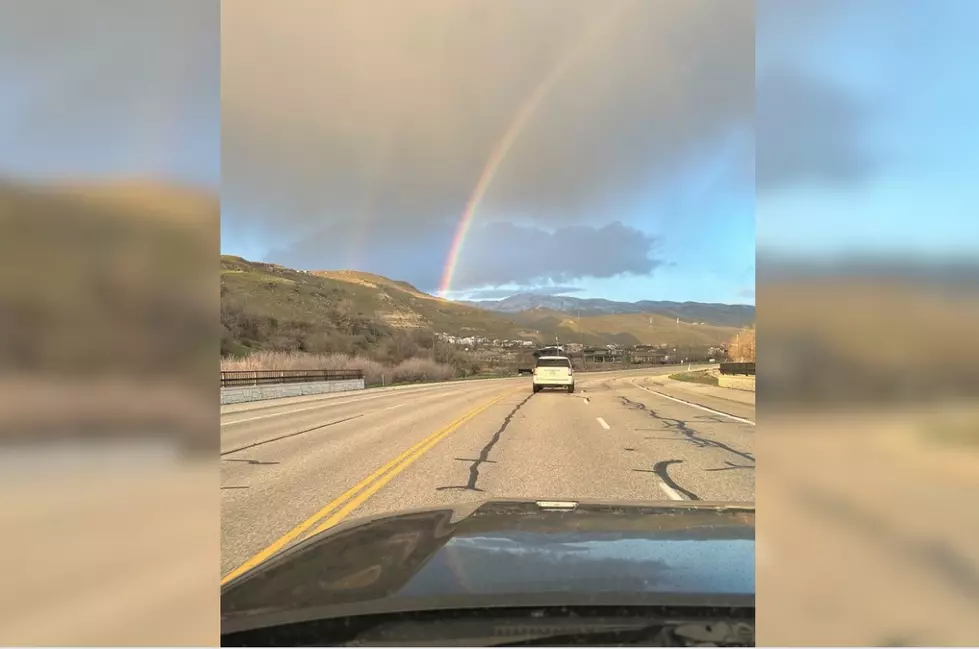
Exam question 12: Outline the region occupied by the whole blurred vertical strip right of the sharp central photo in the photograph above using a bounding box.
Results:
[755,0,979,646]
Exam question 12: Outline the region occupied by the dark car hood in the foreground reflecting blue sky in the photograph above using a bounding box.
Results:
[221,501,755,633]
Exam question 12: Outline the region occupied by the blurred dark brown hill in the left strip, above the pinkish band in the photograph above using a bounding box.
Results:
[0,179,220,376]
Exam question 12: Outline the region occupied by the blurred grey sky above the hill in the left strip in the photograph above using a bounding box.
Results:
[0,0,221,191]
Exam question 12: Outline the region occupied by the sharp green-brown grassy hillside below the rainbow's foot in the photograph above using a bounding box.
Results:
[221,256,735,362]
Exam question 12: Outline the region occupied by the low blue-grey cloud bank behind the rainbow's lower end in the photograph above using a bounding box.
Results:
[269,222,661,291]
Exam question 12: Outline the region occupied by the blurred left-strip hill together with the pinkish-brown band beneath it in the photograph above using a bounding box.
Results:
[0,178,220,450]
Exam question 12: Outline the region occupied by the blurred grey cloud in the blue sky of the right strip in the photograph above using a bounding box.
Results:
[755,68,876,192]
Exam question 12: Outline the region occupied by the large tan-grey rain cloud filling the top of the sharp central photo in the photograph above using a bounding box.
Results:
[221,0,754,276]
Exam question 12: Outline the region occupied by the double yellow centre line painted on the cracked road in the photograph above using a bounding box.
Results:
[221,390,514,586]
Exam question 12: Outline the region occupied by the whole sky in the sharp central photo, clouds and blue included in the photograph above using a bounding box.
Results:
[221,0,755,303]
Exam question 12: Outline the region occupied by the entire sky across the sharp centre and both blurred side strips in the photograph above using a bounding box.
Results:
[0,0,979,303]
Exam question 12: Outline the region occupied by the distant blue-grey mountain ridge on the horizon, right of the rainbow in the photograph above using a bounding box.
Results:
[465,293,755,327]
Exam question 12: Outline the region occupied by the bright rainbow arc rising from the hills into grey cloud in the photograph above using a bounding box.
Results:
[438,0,636,298]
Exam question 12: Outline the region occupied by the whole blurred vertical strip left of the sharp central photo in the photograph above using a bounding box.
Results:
[0,0,220,646]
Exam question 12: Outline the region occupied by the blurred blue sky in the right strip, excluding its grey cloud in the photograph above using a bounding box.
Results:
[757,0,979,257]
